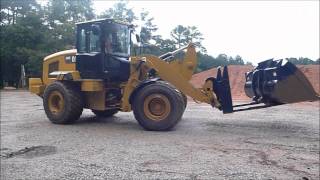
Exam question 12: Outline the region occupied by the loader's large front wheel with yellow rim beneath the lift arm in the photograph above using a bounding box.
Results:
[132,81,185,131]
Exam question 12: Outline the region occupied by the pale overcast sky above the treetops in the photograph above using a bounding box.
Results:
[93,0,320,64]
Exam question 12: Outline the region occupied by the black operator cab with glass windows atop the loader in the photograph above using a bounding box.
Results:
[76,19,132,82]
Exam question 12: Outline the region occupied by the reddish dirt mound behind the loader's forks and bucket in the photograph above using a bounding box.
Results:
[191,65,320,100]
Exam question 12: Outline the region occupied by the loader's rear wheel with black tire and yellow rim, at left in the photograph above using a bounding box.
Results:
[43,81,83,124]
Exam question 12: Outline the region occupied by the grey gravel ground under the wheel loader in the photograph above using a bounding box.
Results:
[0,91,319,180]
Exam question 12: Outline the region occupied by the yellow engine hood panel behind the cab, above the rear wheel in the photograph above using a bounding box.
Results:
[42,49,77,85]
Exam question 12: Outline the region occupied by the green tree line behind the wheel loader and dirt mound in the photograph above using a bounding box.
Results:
[0,0,319,86]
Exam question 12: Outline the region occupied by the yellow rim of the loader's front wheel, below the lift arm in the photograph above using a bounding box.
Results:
[143,94,171,121]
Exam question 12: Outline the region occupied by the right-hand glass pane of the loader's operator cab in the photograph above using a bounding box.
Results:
[103,24,130,56]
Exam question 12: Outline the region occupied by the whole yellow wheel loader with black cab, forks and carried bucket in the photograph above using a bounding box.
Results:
[29,19,319,131]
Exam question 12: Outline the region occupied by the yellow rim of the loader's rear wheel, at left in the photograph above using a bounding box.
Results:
[48,91,64,114]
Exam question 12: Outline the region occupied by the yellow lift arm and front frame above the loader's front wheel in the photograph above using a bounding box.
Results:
[121,44,220,111]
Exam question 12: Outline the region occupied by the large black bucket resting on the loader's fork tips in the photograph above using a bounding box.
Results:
[244,59,319,104]
